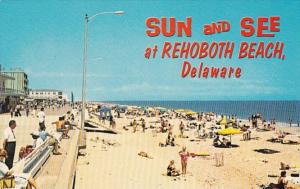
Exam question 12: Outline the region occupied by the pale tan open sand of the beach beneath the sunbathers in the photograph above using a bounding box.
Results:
[76,108,300,189]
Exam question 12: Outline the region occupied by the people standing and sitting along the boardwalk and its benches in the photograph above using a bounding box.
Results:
[0,103,78,189]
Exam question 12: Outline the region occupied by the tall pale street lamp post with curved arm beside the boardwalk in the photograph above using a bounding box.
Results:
[80,11,124,131]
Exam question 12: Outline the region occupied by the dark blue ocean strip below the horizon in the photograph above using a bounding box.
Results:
[109,101,300,124]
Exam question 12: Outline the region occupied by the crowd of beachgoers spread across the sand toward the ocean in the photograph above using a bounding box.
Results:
[101,104,300,189]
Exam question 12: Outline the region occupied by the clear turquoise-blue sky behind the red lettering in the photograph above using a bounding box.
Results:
[0,0,300,101]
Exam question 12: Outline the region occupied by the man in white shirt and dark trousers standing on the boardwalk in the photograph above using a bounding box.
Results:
[3,120,17,169]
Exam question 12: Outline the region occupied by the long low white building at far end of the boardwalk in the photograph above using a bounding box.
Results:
[28,89,68,102]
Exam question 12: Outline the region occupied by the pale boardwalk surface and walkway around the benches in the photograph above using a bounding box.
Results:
[0,107,79,189]
